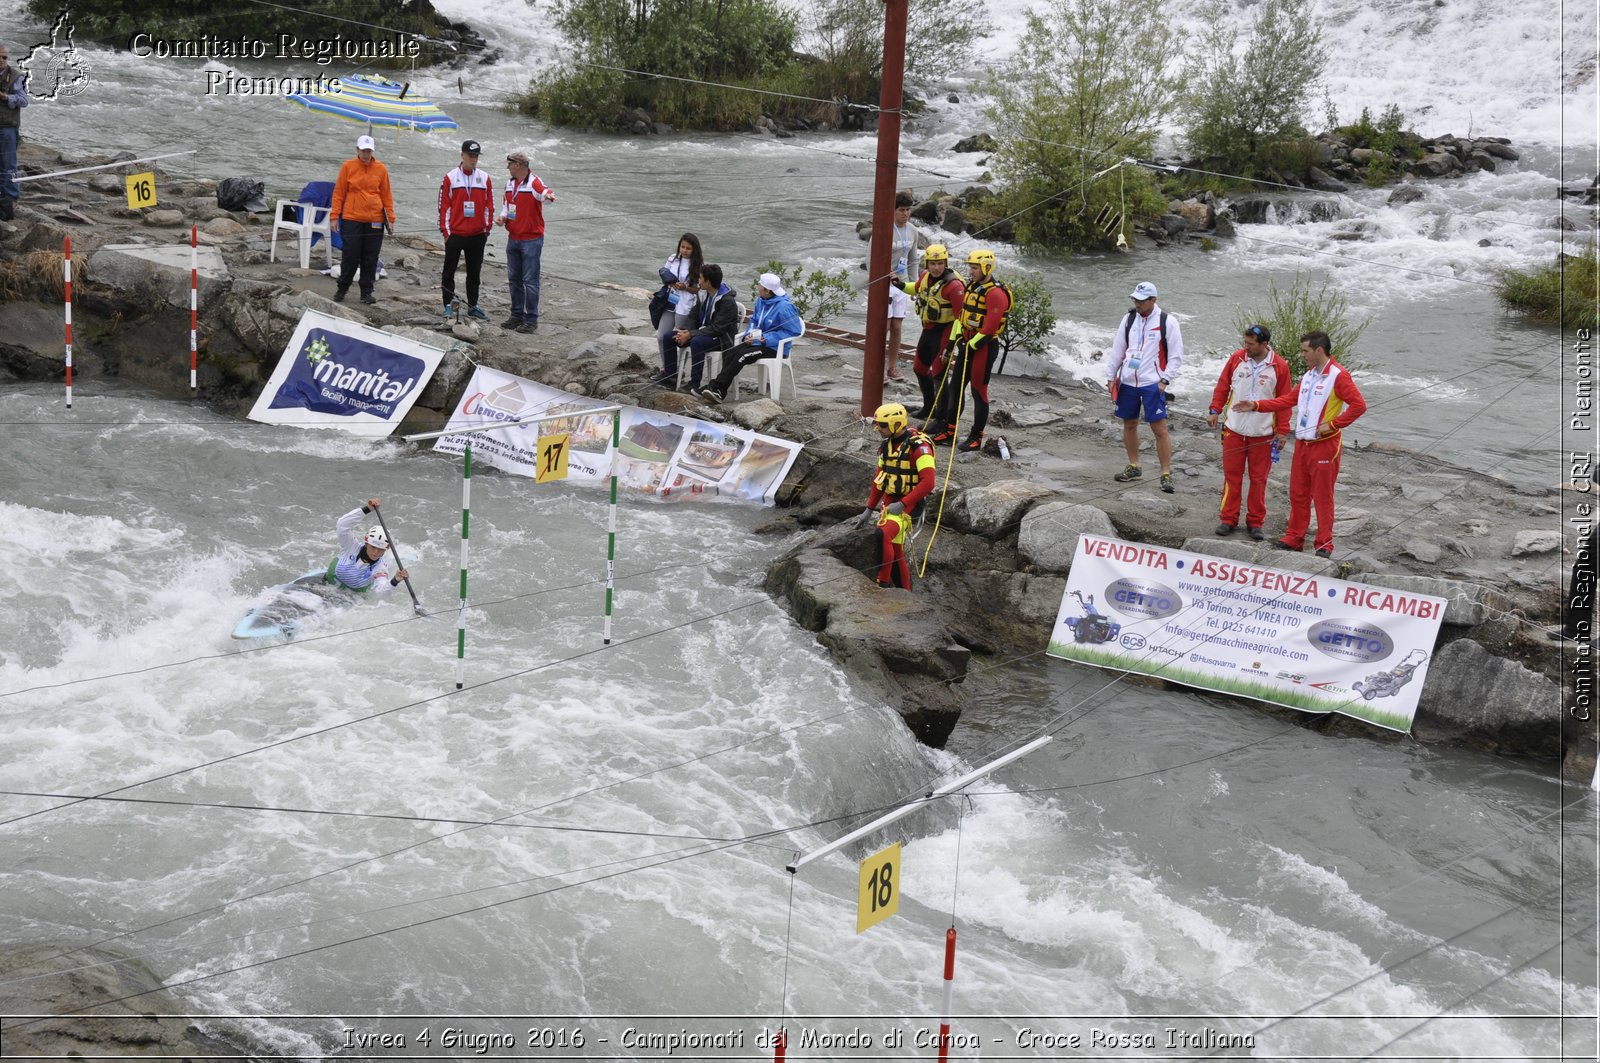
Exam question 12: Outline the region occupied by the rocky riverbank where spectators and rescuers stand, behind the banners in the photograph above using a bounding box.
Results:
[0,146,1595,778]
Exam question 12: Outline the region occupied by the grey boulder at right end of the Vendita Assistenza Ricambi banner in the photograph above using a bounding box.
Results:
[1413,639,1562,757]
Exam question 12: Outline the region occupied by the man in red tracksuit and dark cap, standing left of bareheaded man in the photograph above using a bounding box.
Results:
[1205,325,1290,541]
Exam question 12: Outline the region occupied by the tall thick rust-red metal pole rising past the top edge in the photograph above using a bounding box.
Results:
[861,0,907,418]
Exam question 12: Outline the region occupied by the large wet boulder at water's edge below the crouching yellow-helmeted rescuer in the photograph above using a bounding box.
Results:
[766,547,971,749]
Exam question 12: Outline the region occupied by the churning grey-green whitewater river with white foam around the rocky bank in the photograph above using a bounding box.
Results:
[0,0,1597,1060]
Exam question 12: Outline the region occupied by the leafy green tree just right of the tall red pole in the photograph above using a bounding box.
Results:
[989,0,1184,250]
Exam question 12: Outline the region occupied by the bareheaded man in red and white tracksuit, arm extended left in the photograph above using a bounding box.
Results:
[1234,331,1366,557]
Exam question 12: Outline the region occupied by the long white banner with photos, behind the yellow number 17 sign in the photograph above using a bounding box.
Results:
[434,367,800,504]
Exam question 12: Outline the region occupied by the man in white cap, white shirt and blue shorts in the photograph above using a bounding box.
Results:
[1106,280,1184,495]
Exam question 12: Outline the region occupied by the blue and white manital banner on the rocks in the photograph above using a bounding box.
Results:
[250,311,445,439]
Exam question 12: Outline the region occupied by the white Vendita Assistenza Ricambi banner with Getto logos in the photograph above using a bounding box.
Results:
[1050,535,1446,732]
